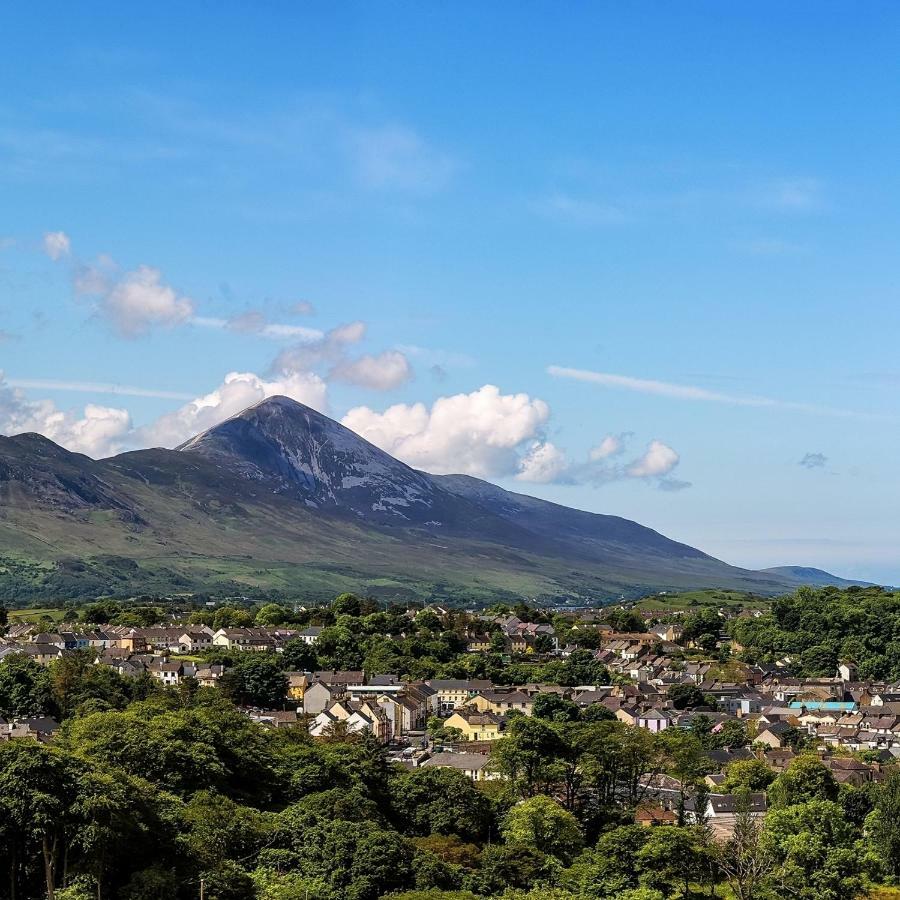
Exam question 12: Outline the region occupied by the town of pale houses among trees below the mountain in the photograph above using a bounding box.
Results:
[0,592,900,852]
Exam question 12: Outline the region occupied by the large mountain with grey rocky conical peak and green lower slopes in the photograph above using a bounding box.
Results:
[0,397,828,603]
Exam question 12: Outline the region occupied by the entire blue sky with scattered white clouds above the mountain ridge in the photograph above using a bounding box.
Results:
[0,2,900,583]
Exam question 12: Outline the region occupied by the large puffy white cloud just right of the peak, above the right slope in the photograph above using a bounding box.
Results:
[342,384,550,477]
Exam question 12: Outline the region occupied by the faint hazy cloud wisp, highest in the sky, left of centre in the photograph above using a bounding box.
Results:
[349,125,456,192]
